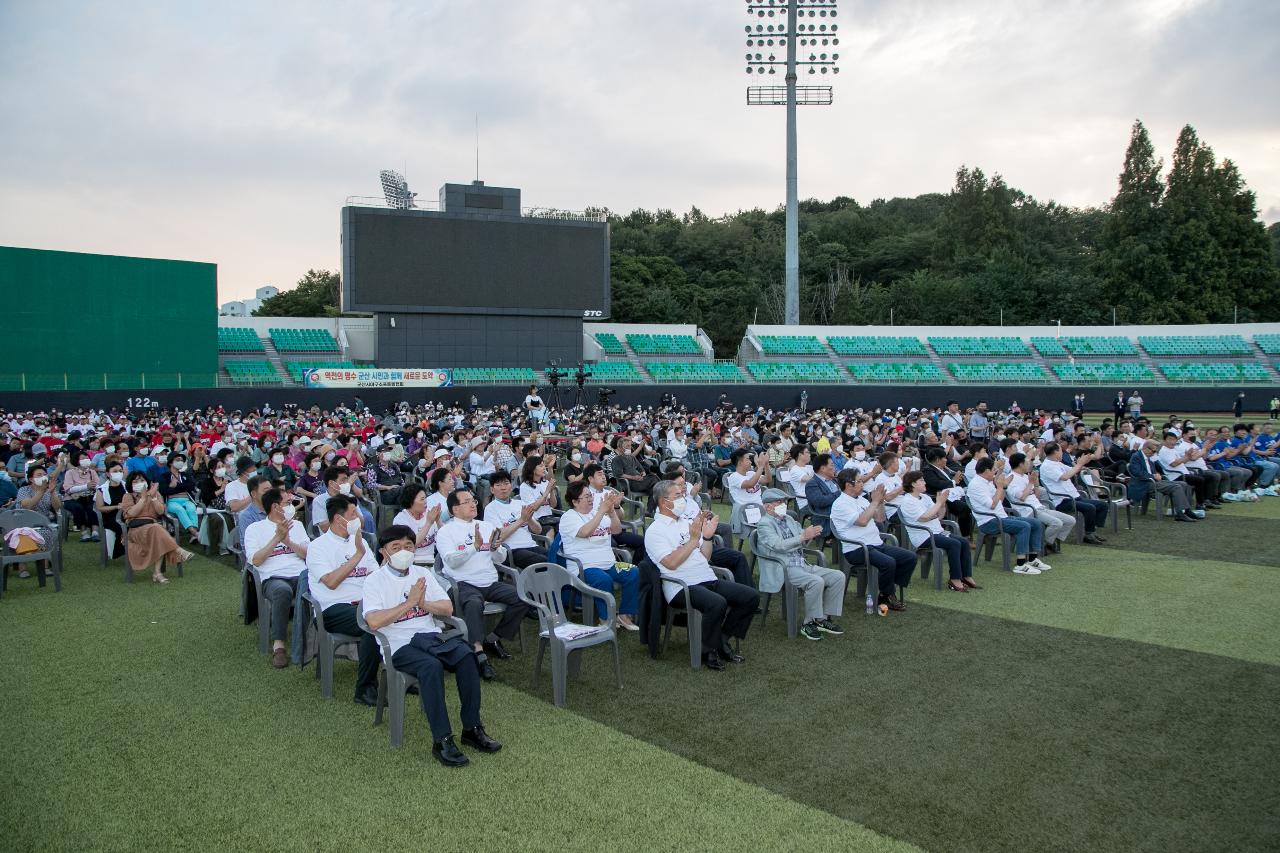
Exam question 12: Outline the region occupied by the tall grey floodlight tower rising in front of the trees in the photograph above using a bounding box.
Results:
[746,0,840,325]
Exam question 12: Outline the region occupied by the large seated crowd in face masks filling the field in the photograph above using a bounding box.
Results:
[0,401,1280,766]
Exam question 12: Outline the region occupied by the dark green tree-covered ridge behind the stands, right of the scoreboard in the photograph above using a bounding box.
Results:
[609,122,1280,357]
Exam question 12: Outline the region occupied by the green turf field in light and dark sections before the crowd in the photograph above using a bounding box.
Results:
[0,489,1280,853]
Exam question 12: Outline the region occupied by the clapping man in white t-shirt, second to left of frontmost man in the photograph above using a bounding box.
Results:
[244,489,311,670]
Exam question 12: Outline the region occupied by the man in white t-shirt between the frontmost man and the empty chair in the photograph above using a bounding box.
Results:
[435,489,529,681]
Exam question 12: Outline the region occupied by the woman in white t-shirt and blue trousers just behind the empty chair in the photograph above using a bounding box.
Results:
[559,480,640,631]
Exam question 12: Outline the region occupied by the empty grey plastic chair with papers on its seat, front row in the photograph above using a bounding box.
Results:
[516,562,622,708]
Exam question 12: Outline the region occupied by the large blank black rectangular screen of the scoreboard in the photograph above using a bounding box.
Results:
[343,207,609,318]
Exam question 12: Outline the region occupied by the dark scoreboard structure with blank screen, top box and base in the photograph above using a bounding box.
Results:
[342,182,609,368]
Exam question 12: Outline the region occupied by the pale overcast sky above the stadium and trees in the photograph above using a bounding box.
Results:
[0,0,1280,301]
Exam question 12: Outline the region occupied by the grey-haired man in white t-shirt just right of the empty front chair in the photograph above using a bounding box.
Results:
[644,480,760,671]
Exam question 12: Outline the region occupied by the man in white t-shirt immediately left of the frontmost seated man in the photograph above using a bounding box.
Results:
[307,492,378,707]
